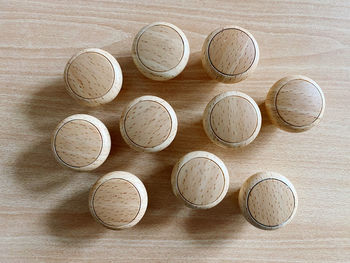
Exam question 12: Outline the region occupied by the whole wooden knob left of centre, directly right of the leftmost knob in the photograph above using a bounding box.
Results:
[120,96,177,152]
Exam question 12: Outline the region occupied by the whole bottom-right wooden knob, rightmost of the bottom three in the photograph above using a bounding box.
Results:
[238,172,298,230]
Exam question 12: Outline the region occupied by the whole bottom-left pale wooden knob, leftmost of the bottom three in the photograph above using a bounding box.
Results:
[89,171,148,230]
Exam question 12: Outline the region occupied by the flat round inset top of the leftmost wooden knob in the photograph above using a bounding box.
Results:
[54,119,102,167]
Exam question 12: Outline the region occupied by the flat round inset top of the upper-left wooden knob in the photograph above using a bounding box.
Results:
[66,52,115,99]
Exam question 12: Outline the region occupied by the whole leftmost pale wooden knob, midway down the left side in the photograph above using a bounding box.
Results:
[51,114,111,171]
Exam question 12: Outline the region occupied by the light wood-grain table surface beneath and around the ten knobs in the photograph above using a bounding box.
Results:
[0,0,350,262]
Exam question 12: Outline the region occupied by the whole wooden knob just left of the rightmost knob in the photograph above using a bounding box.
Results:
[203,91,261,148]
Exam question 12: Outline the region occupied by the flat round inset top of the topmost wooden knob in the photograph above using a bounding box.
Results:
[137,25,184,72]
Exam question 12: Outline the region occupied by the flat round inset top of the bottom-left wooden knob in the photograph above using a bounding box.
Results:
[93,179,141,228]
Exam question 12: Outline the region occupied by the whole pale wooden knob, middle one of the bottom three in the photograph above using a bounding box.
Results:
[171,151,230,209]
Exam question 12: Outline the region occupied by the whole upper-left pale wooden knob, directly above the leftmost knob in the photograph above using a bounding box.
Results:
[64,48,123,106]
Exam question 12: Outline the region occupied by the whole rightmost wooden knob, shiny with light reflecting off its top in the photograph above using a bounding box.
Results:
[265,75,325,132]
